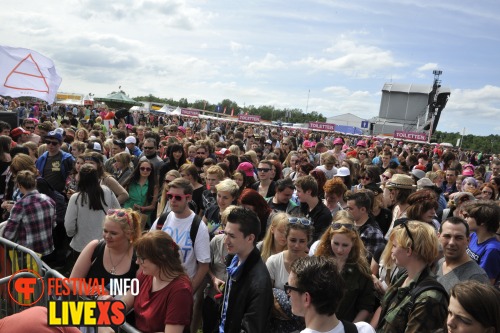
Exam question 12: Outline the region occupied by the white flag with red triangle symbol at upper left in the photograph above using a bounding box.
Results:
[0,45,62,104]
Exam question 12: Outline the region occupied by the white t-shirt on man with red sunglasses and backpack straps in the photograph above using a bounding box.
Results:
[150,212,210,279]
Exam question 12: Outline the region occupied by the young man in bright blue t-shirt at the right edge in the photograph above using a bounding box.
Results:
[464,201,500,286]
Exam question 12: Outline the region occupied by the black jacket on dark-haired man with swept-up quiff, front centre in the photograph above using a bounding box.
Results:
[224,248,274,333]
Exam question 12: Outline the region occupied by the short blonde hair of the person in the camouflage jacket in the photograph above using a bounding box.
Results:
[388,221,439,265]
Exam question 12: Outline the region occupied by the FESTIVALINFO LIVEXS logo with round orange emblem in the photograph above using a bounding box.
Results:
[8,269,139,326]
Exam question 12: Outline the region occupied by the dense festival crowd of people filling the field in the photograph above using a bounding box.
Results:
[0,103,500,333]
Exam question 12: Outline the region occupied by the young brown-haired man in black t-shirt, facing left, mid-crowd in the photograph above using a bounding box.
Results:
[295,175,332,244]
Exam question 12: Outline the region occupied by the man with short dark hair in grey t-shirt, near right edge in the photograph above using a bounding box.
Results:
[436,216,489,293]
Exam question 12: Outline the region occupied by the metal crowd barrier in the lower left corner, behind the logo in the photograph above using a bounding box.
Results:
[0,237,141,333]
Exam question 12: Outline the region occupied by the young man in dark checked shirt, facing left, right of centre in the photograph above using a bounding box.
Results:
[345,192,385,262]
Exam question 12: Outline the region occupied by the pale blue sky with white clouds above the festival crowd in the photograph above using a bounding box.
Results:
[0,0,500,135]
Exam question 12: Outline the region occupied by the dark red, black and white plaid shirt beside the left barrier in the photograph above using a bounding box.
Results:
[3,190,56,255]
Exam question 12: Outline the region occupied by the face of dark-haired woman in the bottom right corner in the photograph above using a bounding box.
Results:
[446,296,488,333]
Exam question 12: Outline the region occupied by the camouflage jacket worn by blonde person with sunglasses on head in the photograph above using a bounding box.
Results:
[377,268,448,333]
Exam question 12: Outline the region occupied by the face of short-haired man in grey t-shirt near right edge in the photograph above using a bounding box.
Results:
[439,222,469,261]
